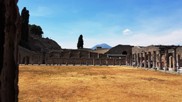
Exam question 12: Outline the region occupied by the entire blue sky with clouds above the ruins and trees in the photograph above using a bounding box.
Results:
[18,0,182,48]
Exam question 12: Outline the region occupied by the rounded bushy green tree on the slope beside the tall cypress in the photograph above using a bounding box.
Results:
[29,24,44,37]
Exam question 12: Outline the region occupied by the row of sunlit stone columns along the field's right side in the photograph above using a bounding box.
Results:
[132,48,177,71]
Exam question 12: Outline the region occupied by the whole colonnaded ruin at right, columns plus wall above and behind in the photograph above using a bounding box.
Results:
[132,45,182,71]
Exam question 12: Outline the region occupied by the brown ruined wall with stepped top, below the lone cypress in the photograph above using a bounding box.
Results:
[39,50,125,65]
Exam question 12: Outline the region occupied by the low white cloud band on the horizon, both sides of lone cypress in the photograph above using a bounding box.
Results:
[55,30,182,48]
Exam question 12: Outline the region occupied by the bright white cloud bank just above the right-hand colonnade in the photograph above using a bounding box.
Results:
[125,30,182,46]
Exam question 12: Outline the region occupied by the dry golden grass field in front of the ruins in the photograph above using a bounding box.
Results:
[19,66,182,102]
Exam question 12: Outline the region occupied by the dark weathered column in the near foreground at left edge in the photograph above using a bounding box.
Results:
[0,0,21,102]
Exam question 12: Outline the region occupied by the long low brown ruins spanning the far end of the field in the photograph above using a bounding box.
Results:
[19,45,132,65]
